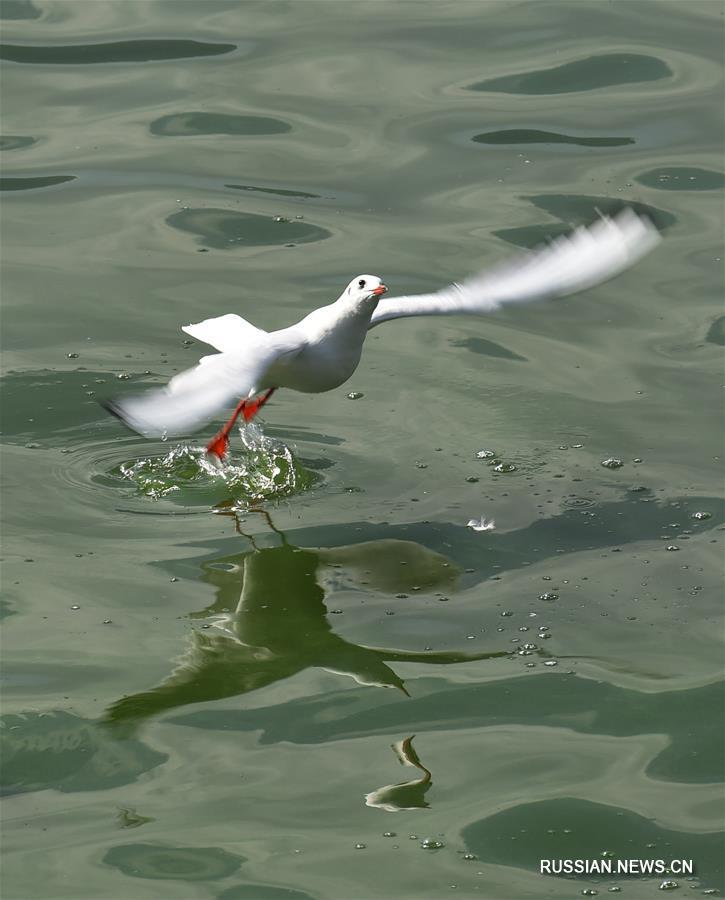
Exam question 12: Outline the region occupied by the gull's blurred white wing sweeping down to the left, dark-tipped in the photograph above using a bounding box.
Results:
[104,332,304,438]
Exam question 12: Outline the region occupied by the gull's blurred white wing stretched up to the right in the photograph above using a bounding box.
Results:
[370,209,661,328]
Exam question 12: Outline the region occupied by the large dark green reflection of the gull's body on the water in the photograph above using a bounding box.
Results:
[105,509,510,725]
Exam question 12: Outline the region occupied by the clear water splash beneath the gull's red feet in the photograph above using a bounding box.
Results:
[113,423,319,506]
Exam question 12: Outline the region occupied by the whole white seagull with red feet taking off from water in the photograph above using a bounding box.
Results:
[103,208,660,461]
